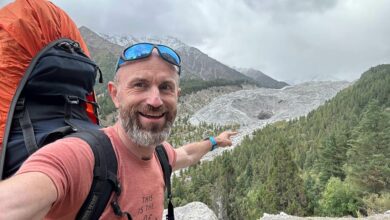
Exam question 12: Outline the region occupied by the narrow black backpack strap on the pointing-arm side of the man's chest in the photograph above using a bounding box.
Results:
[156,144,175,220]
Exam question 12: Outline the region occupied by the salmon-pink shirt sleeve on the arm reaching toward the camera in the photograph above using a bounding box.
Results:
[16,137,94,215]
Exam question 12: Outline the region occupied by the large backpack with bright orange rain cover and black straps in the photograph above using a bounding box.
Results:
[0,0,173,219]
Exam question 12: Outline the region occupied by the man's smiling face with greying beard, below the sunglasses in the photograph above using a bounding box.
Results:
[114,51,179,147]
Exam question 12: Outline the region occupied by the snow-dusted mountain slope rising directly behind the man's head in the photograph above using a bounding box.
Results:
[80,27,286,88]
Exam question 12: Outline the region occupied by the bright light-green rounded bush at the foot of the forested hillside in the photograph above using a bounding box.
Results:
[319,177,362,217]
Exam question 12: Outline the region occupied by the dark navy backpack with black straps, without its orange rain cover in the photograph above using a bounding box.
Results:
[0,39,173,219]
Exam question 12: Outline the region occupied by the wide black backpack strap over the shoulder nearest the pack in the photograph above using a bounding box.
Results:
[70,130,120,220]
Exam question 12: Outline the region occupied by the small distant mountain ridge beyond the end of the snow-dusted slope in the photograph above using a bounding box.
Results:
[237,68,288,89]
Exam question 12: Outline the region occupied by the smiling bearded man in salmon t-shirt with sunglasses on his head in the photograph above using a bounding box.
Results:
[0,44,236,219]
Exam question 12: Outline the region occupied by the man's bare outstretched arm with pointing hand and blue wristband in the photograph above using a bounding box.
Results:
[173,131,237,170]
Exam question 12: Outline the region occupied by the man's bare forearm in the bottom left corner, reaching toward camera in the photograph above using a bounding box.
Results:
[0,172,57,220]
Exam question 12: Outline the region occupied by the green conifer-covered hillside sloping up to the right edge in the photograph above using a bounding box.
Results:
[172,65,390,219]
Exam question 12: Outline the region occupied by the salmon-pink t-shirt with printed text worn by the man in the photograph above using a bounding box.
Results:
[17,125,176,220]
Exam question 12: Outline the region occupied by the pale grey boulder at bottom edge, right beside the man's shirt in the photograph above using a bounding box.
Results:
[162,202,218,220]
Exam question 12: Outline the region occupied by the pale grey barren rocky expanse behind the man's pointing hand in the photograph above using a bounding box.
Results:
[190,81,351,160]
